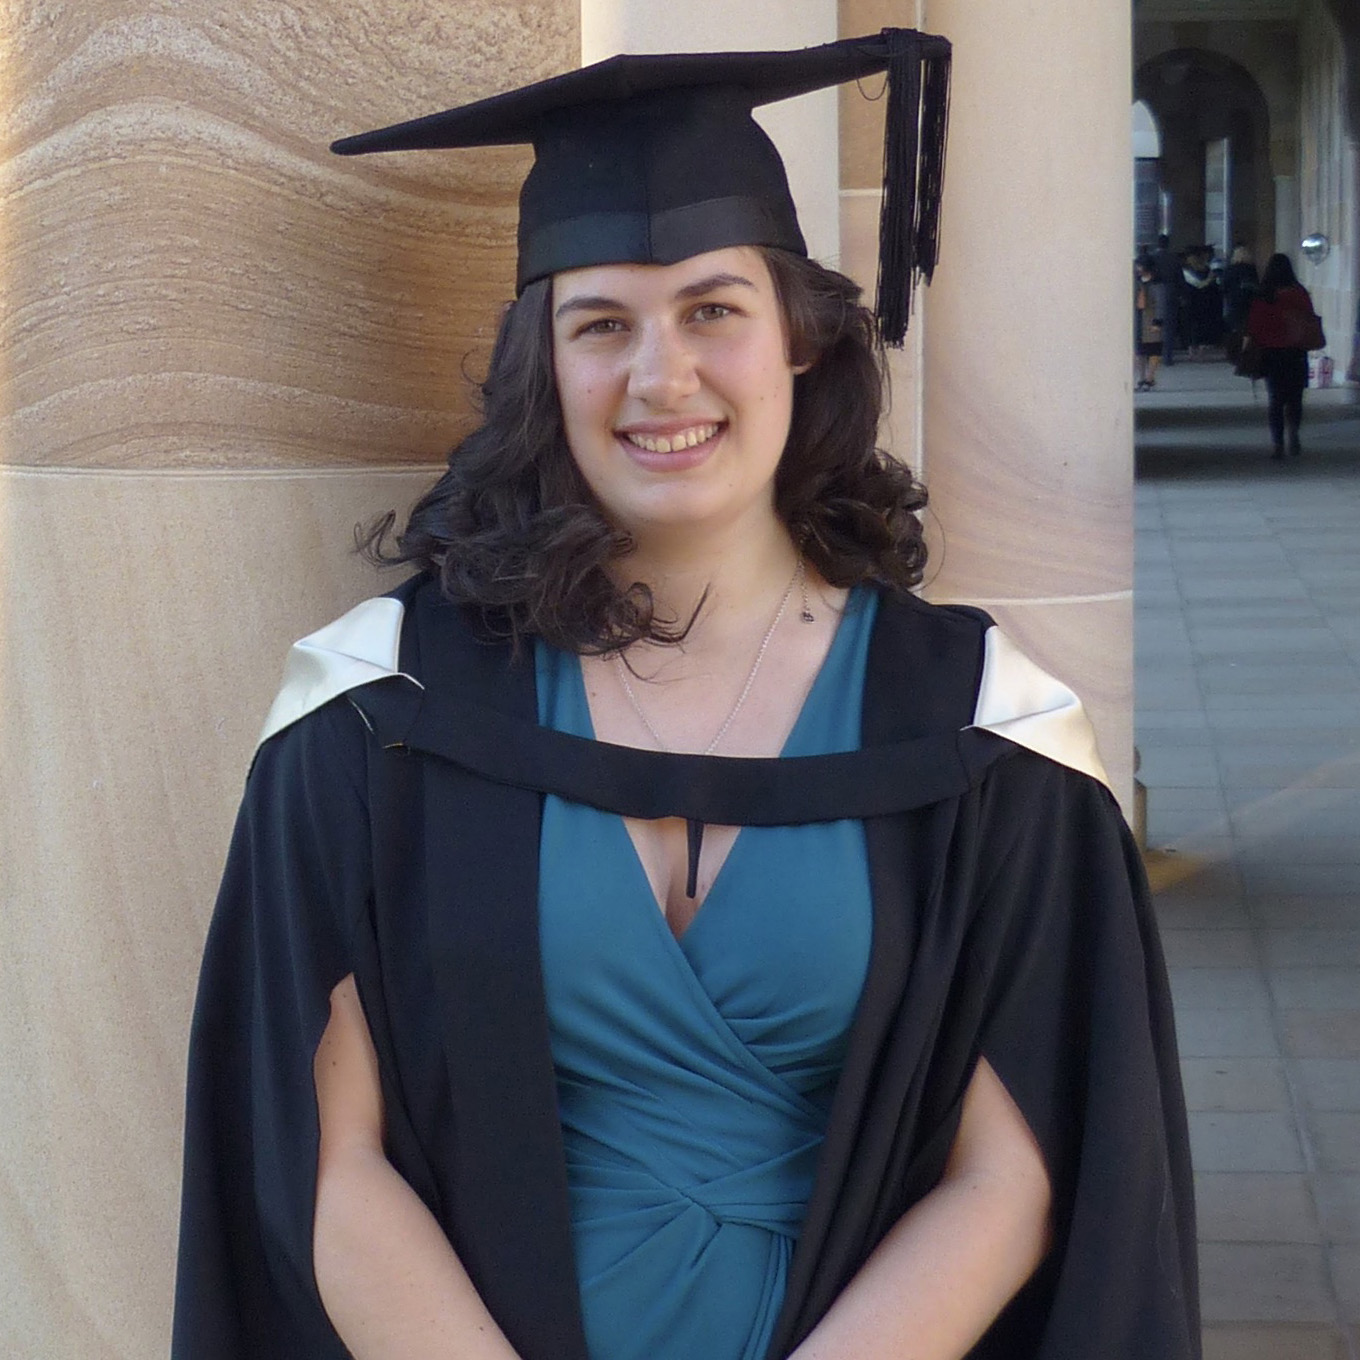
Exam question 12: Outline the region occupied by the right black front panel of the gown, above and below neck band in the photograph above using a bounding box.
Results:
[768,596,1005,1356]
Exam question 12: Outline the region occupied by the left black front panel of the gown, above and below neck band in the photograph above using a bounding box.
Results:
[404,589,586,1360]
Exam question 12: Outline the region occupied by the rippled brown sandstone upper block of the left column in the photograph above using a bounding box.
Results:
[0,0,579,469]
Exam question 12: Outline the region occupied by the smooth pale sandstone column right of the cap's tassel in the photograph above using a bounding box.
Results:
[898,0,1133,809]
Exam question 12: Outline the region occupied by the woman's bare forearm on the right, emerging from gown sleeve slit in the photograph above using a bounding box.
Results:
[792,1058,1051,1360]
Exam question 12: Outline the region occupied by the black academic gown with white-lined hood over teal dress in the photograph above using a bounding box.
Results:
[173,577,1200,1360]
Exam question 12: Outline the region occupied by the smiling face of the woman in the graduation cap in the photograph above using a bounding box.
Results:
[552,246,802,540]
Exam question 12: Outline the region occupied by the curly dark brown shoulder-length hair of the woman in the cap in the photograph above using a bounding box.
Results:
[356,248,926,654]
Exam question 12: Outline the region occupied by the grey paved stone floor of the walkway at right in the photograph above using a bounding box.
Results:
[1136,363,1360,1360]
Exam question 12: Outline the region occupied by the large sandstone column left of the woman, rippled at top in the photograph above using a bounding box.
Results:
[0,0,579,1360]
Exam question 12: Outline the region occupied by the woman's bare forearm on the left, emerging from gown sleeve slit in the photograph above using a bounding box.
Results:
[313,975,515,1360]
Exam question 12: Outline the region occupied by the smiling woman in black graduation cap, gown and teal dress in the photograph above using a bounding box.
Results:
[175,30,1197,1360]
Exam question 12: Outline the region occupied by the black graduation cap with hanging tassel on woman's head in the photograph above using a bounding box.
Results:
[330,29,949,344]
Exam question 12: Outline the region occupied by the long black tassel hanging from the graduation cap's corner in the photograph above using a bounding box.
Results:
[876,29,951,345]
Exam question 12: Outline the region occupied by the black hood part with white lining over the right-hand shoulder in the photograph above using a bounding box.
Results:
[865,596,1110,786]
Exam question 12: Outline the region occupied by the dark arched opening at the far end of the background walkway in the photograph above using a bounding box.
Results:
[1133,48,1276,258]
